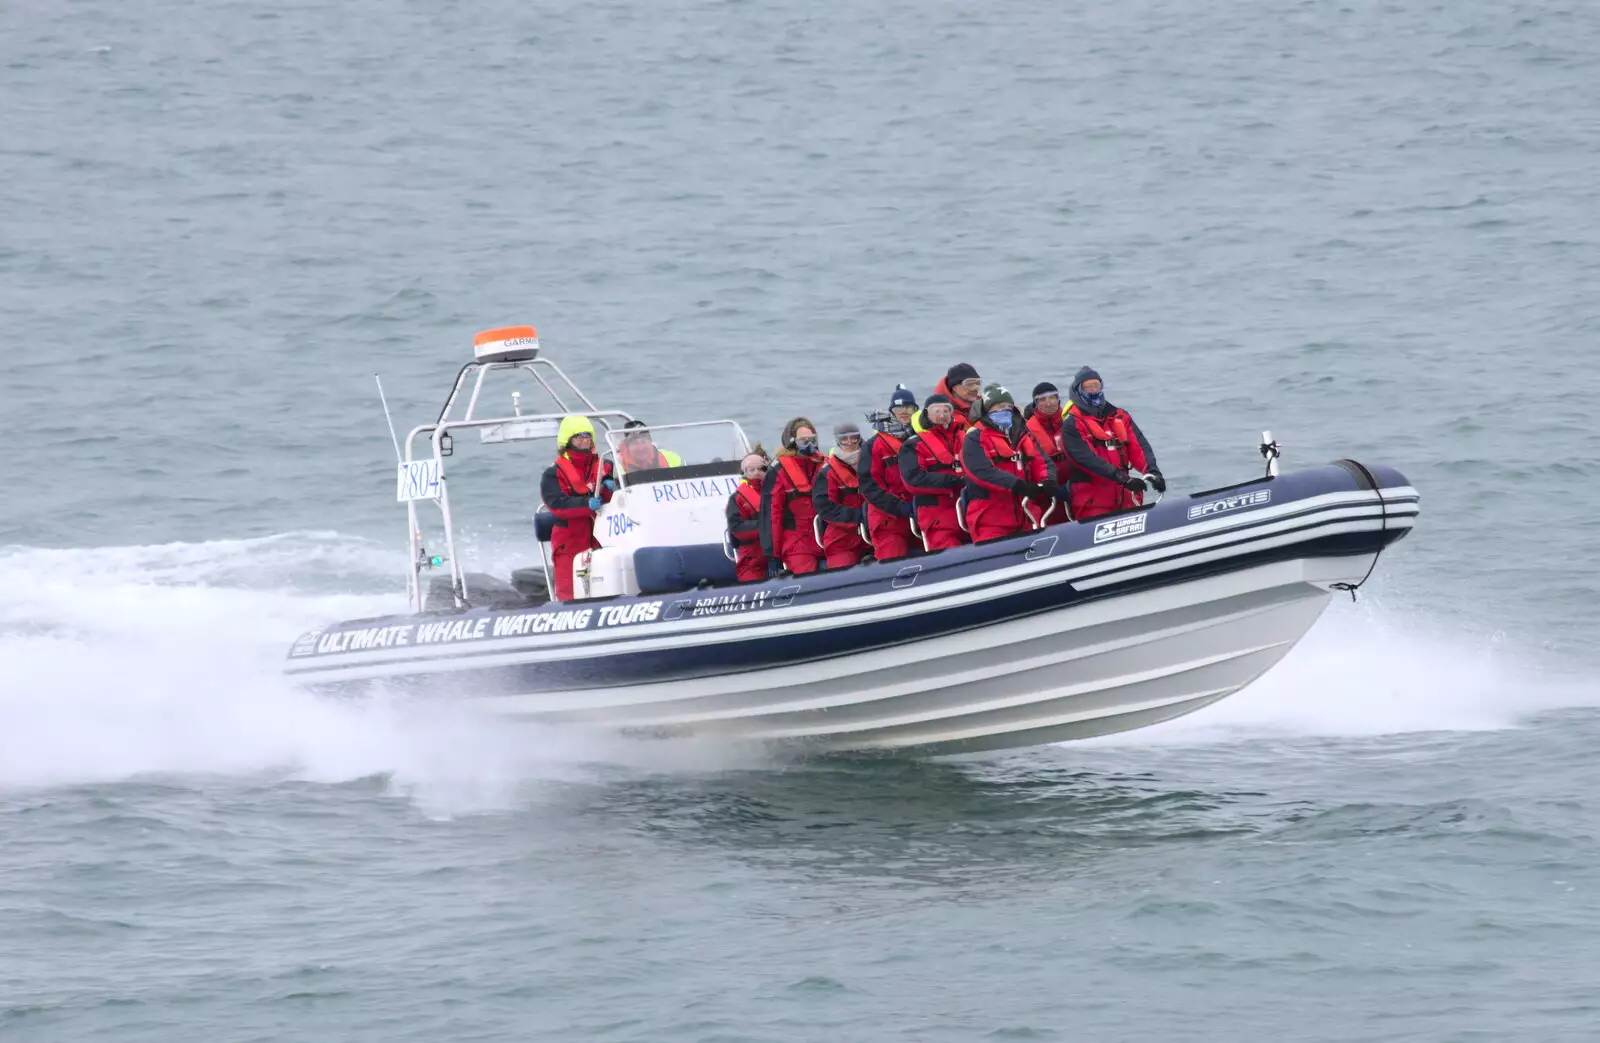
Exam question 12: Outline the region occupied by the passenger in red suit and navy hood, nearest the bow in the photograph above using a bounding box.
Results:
[1061,366,1166,522]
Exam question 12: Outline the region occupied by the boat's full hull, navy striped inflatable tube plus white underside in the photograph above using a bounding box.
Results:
[288,466,1418,753]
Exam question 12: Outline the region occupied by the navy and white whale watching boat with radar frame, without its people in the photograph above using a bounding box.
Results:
[286,326,1418,755]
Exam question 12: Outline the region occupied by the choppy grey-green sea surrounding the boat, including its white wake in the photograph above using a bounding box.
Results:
[0,0,1600,1043]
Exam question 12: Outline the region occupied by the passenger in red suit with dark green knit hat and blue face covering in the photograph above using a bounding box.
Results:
[962,384,1056,544]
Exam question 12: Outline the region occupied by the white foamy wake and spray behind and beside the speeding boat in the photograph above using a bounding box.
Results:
[0,533,1600,813]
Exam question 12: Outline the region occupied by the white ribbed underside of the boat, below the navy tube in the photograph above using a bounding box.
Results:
[483,555,1373,753]
